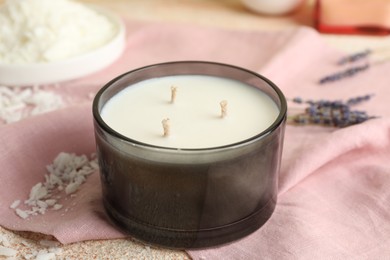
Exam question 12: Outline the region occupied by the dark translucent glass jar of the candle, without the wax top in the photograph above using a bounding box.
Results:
[93,61,287,248]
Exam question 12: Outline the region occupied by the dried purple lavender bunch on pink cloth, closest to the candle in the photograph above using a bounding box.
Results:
[289,95,376,127]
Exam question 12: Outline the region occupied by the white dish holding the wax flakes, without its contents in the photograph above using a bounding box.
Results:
[0,7,125,86]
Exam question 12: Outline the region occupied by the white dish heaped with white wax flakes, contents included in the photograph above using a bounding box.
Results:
[0,0,125,86]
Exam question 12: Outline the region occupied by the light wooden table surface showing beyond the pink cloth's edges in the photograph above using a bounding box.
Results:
[0,0,390,259]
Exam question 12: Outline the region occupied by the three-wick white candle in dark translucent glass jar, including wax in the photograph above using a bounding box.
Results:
[93,61,286,248]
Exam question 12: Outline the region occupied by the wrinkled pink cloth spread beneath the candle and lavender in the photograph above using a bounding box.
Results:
[0,23,390,259]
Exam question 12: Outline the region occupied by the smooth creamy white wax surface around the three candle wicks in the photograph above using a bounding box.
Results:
[101,75,279,149]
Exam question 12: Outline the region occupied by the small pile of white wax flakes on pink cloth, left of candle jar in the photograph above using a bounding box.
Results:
[10,152,98,219]
